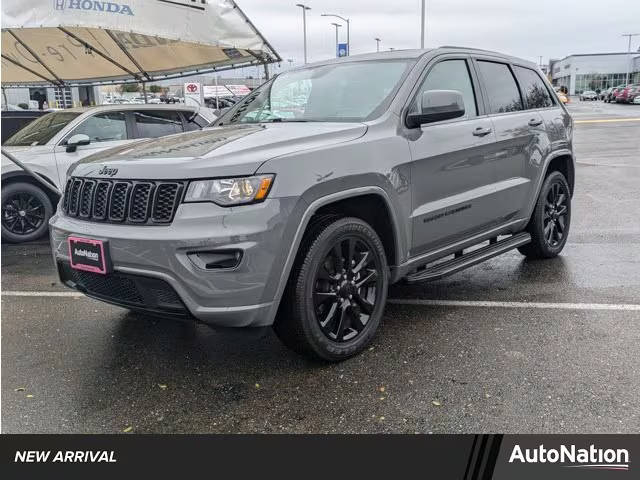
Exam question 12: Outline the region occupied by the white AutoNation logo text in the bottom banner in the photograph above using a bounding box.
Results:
[509,445,629,470]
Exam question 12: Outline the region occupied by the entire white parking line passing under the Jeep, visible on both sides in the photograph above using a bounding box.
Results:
[2,291,640,312]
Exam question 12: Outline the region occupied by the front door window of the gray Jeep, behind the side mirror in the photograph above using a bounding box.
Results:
[411,60,478,117]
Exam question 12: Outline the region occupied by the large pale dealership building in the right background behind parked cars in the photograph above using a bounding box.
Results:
[549,52,640,95]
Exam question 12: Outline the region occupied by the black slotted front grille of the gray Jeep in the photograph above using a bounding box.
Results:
[62,178,185,225]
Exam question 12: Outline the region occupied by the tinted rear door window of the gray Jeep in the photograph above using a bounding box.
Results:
[478,61,523,113]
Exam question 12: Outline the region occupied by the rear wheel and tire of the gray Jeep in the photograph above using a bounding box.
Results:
[518,171,571,259]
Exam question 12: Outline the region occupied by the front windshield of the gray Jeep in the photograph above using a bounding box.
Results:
[216,60,413,125]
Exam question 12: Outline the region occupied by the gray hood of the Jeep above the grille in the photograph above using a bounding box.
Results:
[69,122,367,180]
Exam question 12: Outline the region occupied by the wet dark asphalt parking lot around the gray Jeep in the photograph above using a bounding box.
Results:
[2,101,640,433]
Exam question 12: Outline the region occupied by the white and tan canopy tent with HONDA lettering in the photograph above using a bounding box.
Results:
[2,0,281,88]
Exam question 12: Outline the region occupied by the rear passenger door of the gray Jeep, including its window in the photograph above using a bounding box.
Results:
[476,58,548,223]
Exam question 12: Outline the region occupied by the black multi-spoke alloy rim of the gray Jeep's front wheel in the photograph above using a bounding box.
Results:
[313,236,381,342]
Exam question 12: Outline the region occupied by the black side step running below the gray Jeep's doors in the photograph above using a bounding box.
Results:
[405,233,531,283]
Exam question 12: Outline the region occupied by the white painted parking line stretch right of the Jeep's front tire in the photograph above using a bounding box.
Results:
[388,298,640,312]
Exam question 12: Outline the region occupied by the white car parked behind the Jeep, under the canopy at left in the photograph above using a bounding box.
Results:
[2,105,216,243]
